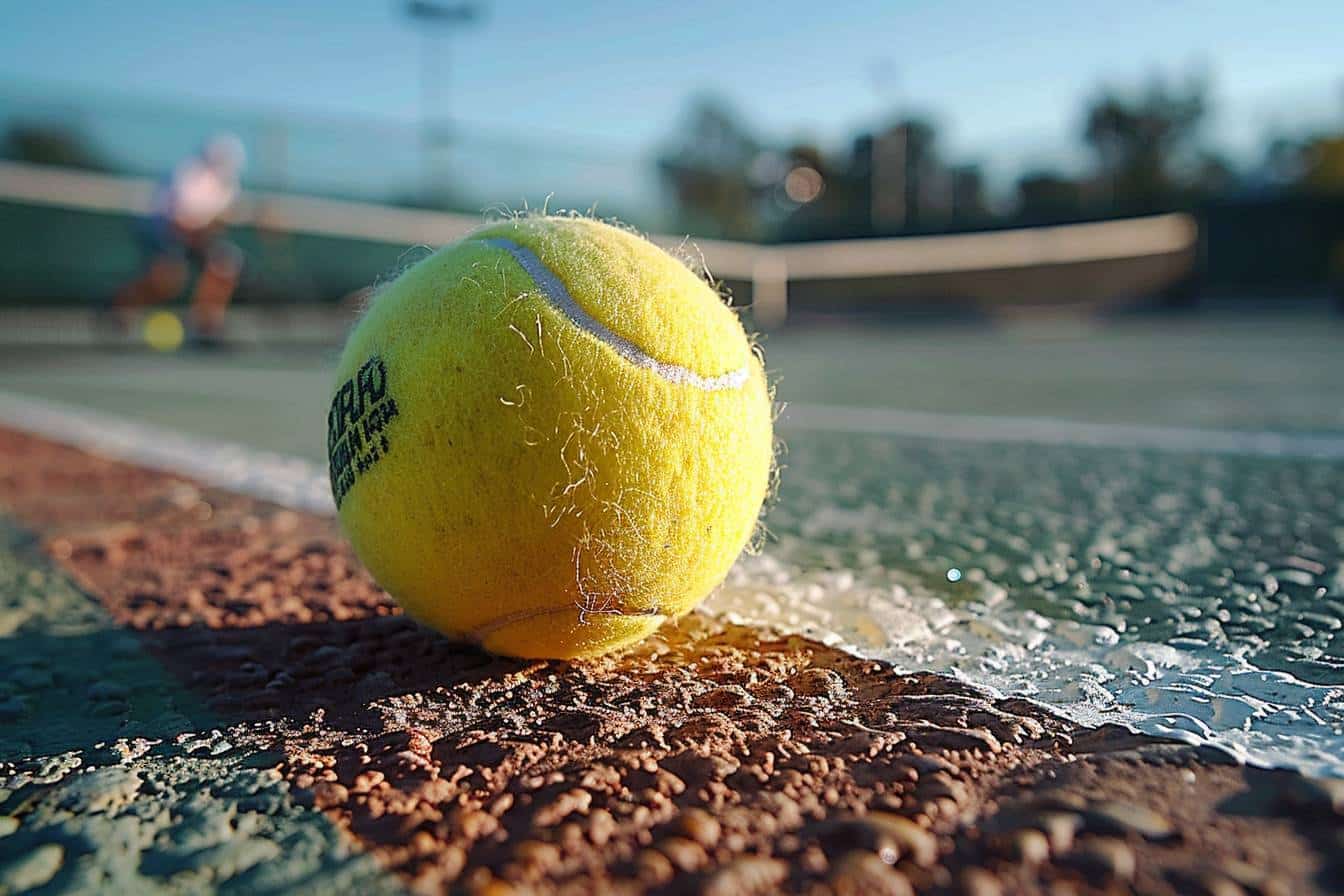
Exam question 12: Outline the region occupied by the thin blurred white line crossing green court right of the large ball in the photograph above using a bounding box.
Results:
[780,403,1344,461]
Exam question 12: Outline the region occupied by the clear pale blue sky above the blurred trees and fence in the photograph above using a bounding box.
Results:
[0,0,1344,174]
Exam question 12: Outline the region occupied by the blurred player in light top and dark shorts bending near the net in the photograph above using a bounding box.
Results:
[112,134,245,344]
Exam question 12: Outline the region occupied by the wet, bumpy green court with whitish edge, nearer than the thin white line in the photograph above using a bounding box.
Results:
[712,433,1344,774]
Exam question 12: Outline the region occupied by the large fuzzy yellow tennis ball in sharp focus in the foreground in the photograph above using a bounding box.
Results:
[328,216,773,658]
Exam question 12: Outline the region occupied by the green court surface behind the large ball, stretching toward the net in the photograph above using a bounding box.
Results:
[0,313,1344,774]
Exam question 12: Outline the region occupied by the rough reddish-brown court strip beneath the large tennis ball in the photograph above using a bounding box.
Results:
[0,430,1344,895]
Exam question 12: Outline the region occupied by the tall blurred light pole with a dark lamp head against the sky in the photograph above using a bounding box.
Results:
[405,0,481,200]
